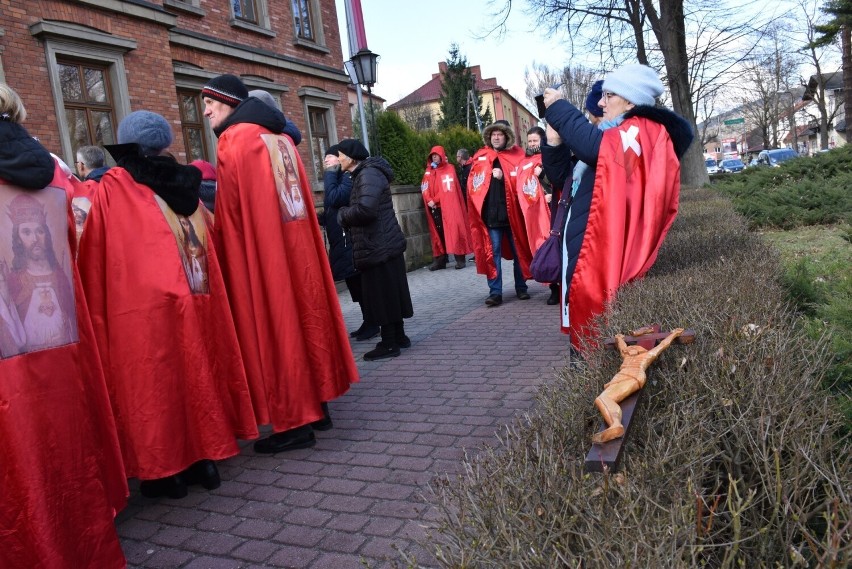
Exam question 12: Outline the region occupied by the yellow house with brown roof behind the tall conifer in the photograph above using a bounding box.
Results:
[388,61,538,146]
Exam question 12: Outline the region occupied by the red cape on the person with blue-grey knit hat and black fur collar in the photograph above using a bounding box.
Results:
[77,168,258,480]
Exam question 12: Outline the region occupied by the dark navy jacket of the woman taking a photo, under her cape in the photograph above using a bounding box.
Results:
[541,100,693,288]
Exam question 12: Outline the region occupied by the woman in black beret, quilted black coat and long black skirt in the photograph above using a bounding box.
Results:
[337,138,414,361]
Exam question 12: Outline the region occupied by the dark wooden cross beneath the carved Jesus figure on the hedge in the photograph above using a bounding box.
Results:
[585,324,695,472]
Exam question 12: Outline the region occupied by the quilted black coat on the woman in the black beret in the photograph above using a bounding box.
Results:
[337,156,405,271]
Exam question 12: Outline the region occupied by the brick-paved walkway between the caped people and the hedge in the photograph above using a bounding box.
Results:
[117,262,567,569]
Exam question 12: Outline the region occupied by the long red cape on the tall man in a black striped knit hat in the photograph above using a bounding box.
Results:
[214,123,358,431]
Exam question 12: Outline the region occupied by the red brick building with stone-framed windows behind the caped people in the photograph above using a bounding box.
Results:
[0,0,352,183]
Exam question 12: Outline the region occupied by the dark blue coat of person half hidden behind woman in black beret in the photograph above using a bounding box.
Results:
[320,164,357,281]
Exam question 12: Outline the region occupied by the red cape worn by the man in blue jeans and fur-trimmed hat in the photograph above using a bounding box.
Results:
[467,146,532,279]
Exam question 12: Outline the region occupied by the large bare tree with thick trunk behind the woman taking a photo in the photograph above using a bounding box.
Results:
[491,0,780,186]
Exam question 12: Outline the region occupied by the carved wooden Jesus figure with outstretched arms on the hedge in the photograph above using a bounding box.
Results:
[592,328,683,443]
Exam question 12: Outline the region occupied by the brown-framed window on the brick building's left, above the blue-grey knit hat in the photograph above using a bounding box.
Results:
[56,60,115,165]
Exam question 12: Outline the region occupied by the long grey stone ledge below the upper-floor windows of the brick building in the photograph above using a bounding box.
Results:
[169,28,349,83]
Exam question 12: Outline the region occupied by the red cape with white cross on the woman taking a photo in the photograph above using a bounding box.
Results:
[563,117,680,348]
